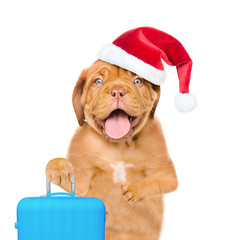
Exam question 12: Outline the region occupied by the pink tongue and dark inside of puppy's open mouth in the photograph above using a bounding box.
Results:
[104,110,131,139]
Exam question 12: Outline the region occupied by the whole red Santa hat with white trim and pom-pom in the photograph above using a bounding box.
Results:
[98,27,197,112]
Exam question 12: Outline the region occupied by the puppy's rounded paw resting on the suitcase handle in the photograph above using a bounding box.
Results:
[46,158,75,185]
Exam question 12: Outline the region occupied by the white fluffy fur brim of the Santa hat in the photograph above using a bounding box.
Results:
[97,43,166,85]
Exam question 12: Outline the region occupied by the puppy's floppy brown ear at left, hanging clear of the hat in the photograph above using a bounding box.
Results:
[73,69,87,126]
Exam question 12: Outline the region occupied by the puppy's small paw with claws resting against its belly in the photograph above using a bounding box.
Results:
[121,184,141,205]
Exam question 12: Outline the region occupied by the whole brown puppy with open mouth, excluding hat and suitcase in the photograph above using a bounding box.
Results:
[46,60,177,240]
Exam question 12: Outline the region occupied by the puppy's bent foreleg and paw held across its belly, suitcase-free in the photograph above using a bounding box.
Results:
[121,160,178,205]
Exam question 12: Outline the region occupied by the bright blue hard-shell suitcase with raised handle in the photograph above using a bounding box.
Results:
[15,179,106,240]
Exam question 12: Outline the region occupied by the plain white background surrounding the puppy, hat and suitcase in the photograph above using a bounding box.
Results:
[0,0,235,240]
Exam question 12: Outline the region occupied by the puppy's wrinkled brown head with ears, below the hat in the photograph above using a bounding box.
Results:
[73,60,160,142]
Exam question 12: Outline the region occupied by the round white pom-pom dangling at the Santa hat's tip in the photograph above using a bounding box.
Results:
[175,93,197,113]
